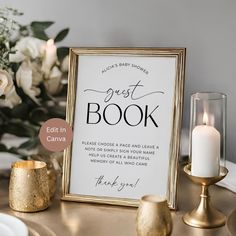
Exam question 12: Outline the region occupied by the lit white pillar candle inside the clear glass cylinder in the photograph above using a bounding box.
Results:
[191,113,220,177]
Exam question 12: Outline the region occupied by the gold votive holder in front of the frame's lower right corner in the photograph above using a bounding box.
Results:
[136,195,172,236]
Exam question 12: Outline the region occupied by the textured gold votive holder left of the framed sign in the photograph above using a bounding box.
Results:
[9,160,50,212]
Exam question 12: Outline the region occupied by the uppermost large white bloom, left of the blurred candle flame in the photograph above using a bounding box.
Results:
[9,37,45,62]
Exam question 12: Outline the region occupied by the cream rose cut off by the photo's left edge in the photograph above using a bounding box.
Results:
[0,70,21,108]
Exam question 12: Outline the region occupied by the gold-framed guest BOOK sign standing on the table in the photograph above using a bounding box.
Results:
[62,48,185,209]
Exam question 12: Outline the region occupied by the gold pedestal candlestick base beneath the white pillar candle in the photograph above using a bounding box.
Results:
[183,164,228,228]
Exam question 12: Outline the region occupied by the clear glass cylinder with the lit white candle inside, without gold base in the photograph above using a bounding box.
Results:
[189,92,227,177]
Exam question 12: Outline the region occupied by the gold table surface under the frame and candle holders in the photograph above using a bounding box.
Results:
[0,171,236,236]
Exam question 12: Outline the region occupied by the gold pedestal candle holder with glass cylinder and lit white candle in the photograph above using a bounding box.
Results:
[183,93,228,228]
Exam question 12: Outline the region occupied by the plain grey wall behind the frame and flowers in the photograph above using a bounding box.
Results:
[0,0,236,162]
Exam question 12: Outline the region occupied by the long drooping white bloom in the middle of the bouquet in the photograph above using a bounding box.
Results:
[16,61,40,104]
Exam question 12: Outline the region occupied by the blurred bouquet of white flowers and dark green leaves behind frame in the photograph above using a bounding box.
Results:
[0,8,69,157]
